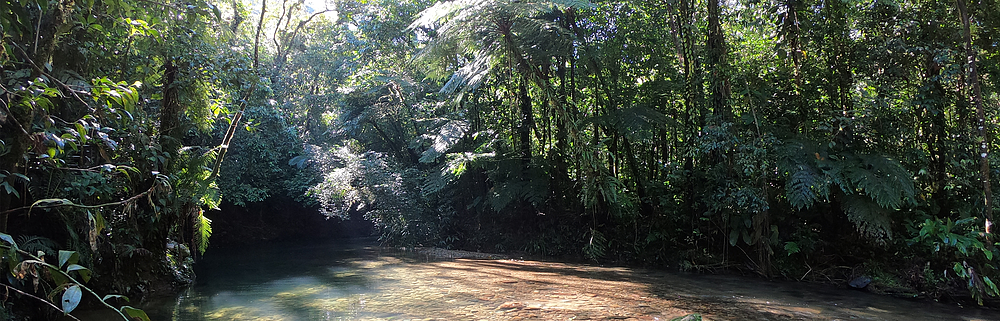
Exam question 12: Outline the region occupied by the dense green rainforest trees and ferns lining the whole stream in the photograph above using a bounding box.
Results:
[0,0,1000,313]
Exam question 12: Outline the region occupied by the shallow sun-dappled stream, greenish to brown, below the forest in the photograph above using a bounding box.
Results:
[74,240,1000,321]
